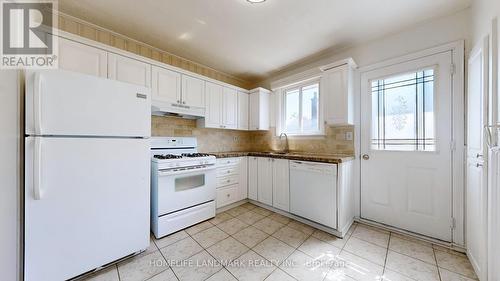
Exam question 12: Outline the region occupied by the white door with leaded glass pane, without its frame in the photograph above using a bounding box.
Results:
[361,51,453,241]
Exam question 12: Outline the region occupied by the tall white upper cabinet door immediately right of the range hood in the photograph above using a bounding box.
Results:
[205,82,223,128]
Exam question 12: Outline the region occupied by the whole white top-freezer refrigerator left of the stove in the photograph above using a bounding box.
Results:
[24,70,151,281]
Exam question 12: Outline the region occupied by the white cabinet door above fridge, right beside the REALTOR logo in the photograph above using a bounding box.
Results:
[59,38,108,77]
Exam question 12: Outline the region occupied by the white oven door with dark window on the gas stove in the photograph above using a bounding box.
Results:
[158,165,216,216]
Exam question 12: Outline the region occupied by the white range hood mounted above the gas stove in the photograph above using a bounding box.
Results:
[151,101,205,119]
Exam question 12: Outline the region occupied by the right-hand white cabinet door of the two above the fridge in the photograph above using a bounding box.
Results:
[108,53,151,87]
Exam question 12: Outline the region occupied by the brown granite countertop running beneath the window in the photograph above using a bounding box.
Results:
[209,151,354,164]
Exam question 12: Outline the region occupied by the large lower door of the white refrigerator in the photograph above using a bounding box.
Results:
[24,137,150,281]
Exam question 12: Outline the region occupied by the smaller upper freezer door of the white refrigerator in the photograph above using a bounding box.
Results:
[26,70,151,137]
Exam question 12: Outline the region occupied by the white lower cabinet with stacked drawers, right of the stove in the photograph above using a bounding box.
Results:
[216,157,248,208]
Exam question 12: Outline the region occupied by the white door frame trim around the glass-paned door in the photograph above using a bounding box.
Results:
[354,40,465,248]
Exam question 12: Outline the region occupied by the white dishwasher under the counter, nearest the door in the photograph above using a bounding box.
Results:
[290,161,337,229]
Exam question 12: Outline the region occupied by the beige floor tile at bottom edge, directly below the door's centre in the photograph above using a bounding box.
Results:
[386,251,439,281]
